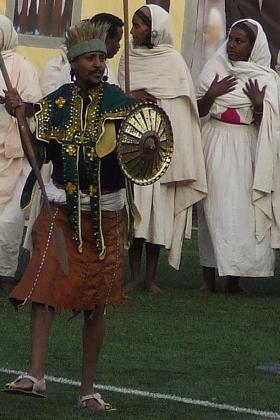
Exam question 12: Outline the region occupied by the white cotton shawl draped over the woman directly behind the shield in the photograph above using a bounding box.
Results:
[119,5,207,269]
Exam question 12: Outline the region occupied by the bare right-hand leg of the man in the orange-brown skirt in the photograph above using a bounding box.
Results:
[80,306,105,410]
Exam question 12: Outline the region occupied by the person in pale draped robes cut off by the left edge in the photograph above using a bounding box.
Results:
[0,15,41,283]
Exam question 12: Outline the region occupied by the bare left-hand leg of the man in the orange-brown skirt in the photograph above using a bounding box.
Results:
[13,303,54,390]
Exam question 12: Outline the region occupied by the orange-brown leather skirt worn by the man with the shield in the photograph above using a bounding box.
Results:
[10,206,124,311]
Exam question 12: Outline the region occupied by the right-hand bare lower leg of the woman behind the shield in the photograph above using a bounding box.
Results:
[145,242,160,293]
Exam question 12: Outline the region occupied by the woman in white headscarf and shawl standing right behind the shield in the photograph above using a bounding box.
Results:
[119,5,207,292]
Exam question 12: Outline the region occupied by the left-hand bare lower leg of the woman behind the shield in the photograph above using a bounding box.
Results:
[125,238,144,291]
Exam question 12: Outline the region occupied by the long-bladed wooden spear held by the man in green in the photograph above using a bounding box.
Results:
[0,52,68,274]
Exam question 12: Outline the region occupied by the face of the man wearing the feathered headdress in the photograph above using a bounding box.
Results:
[71,51,106,87]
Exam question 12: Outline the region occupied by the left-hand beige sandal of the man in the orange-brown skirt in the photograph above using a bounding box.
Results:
[3,375,46,398]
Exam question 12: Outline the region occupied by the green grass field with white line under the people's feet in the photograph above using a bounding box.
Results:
[0,235,280,420]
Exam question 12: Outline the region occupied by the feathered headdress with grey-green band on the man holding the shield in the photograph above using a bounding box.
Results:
[65,21,110,62]
